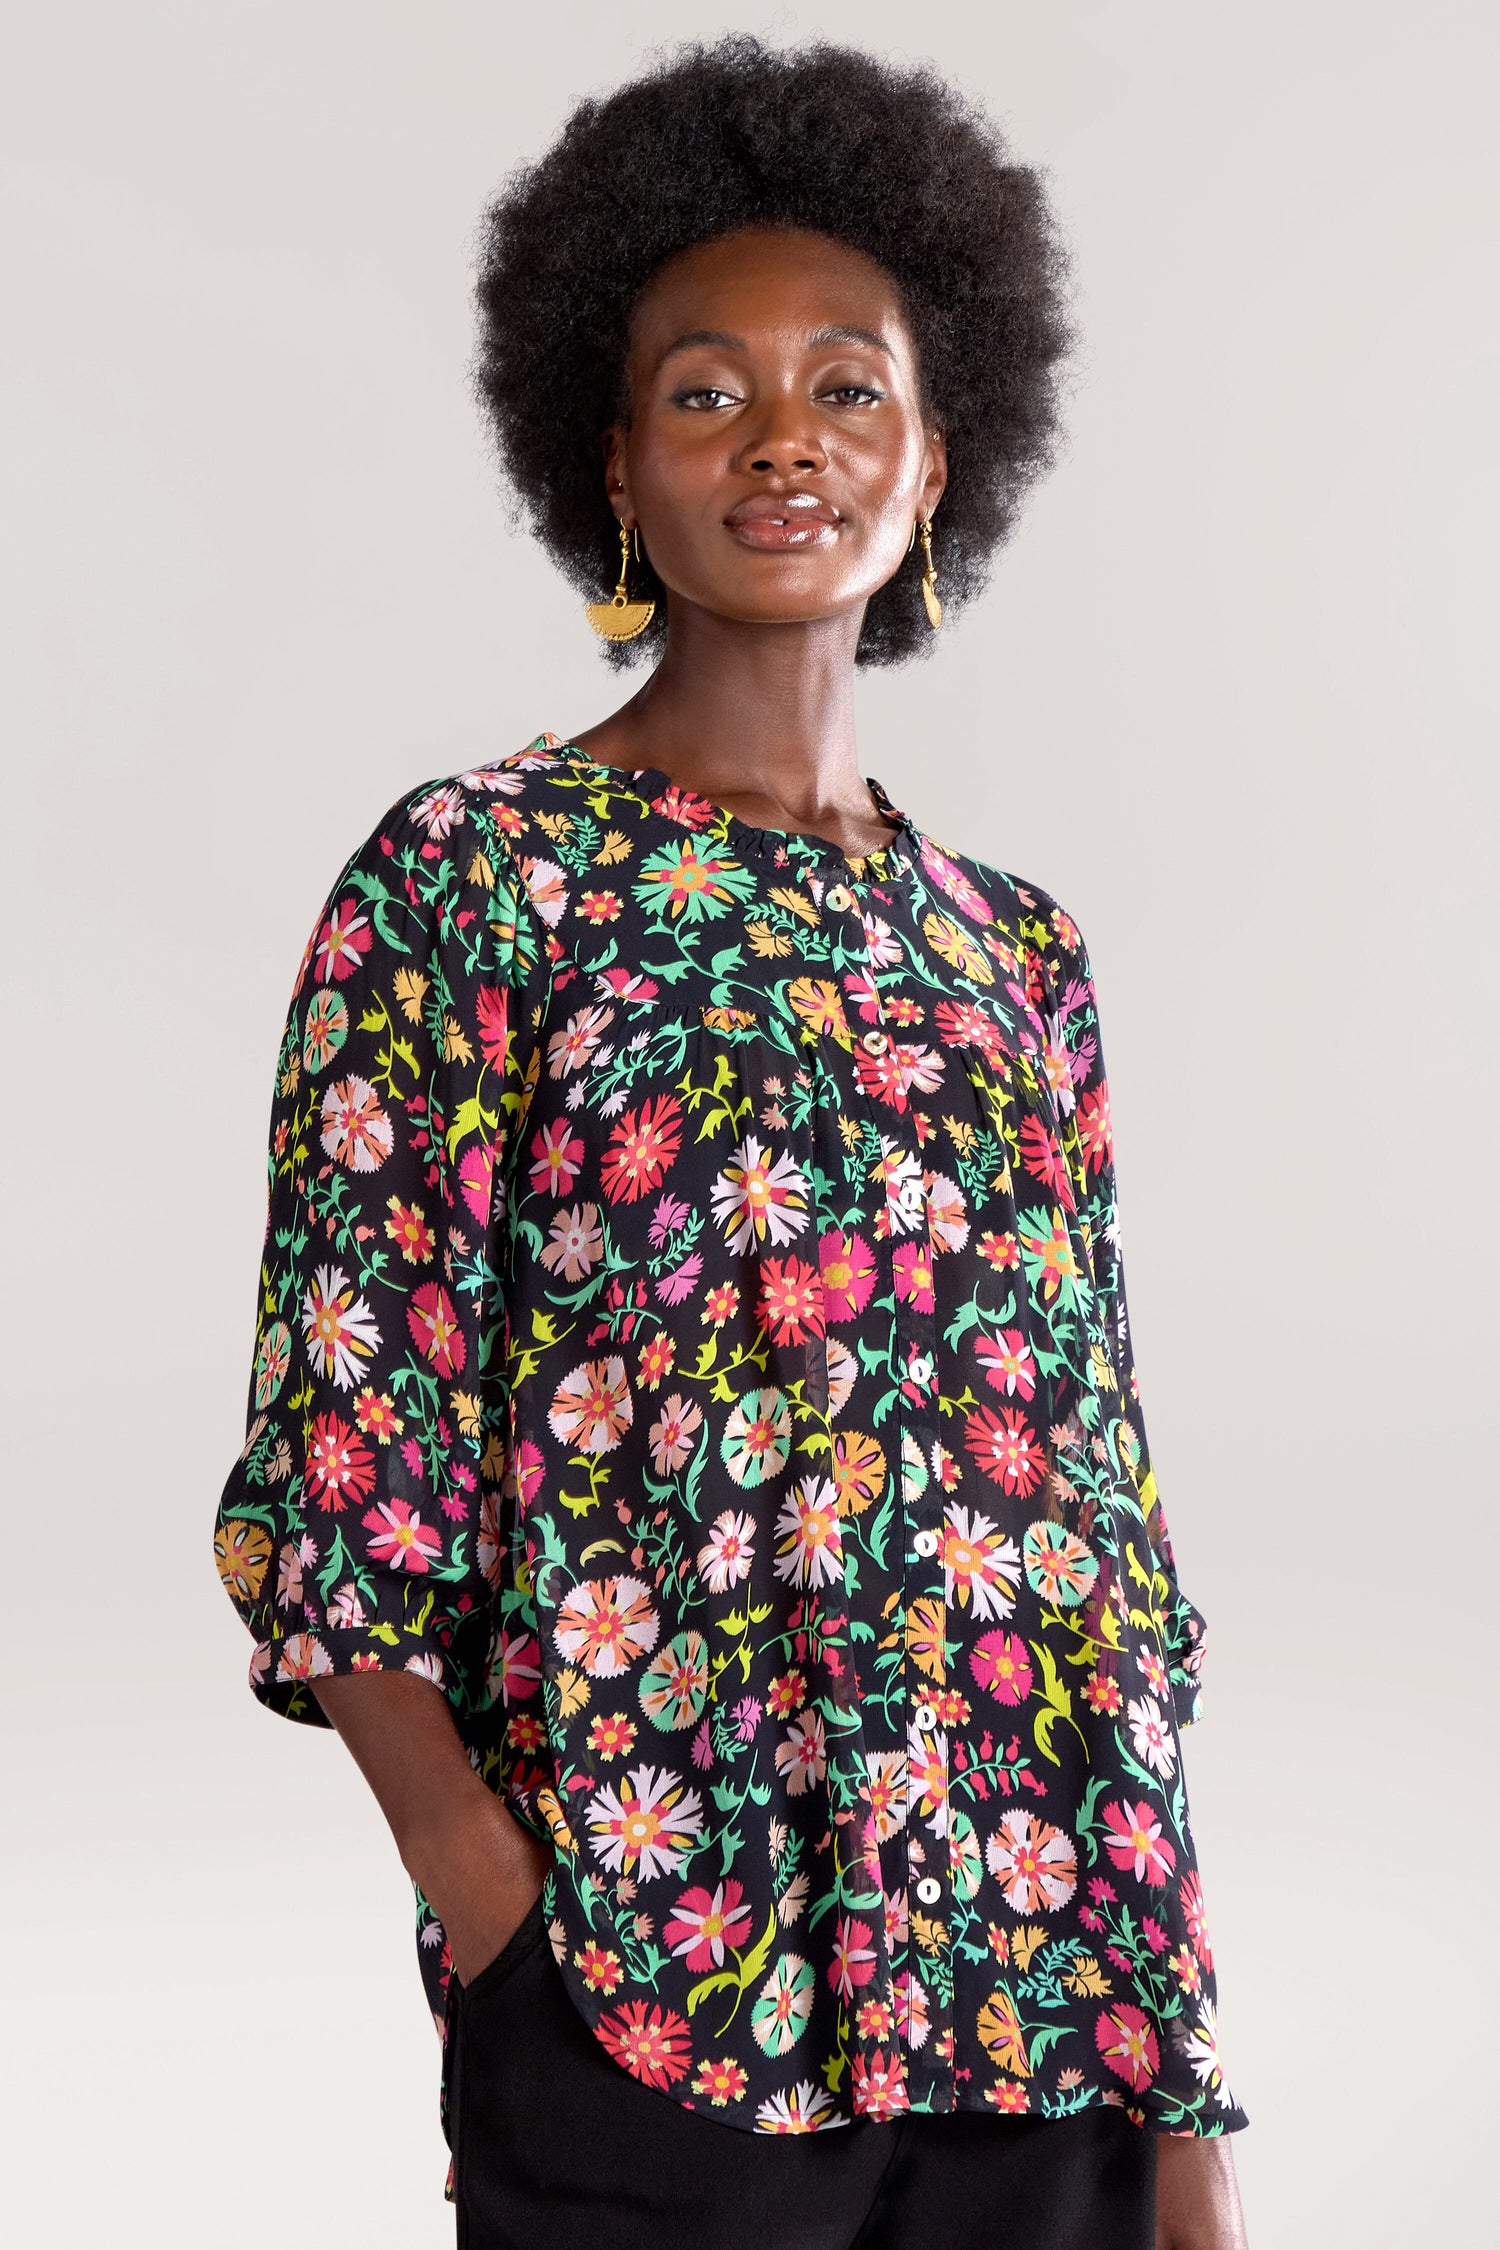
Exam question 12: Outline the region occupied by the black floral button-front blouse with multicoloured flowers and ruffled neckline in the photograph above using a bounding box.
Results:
[216,734,1246,2196]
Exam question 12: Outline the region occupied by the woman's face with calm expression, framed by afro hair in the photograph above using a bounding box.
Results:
[605,227,947,623]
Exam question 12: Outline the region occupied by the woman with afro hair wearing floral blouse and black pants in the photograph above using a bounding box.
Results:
[218,38,1244,2250]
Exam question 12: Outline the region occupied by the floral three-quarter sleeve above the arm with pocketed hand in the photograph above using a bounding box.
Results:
[214,788,549,1726]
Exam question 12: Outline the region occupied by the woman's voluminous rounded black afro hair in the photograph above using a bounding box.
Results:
[475,34,1075,664]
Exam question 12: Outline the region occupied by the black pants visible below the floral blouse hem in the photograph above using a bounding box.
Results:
[448,1901,1156,2250]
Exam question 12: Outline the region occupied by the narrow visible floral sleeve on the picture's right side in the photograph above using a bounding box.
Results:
[1043,907,1205,1726]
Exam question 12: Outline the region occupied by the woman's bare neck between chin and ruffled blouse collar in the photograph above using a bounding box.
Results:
[573,603,870,828]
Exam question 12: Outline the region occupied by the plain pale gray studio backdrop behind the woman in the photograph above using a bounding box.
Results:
[0,0,1500,2250]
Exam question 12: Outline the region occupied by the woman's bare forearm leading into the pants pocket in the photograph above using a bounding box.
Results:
[313,1672,551,1978]
